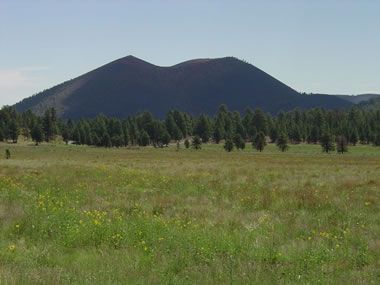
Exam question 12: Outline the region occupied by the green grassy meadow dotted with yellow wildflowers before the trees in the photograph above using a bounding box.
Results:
[0,144,380,284]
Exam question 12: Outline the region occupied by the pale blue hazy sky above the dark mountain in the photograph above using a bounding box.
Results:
[0,0,380,107]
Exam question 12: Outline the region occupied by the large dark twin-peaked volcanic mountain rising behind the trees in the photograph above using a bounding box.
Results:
[15,56,352,119]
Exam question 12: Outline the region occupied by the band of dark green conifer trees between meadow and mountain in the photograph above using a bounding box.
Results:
[0,105,380,153]
